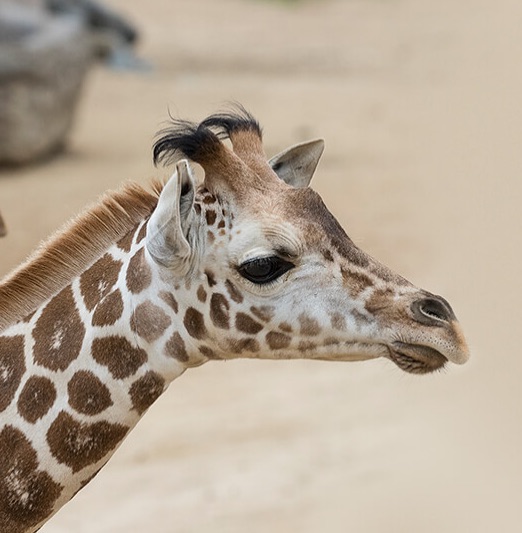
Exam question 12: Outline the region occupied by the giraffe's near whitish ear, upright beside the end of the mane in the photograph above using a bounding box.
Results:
[146,159,195,274]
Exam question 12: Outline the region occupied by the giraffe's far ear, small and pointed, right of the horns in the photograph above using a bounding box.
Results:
[268,139,324,188]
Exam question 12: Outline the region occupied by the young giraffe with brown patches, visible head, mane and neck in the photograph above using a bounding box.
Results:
[0,106,468,533]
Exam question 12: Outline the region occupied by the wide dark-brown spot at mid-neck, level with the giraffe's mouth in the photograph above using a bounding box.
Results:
[92,335,147,379]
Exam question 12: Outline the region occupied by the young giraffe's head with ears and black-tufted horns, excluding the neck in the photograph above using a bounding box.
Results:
[146,108,468,373]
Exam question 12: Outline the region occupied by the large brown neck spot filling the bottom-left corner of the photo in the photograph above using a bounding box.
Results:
[0,426,63,533]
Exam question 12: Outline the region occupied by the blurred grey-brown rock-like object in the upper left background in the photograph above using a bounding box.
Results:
[0,0,143,164]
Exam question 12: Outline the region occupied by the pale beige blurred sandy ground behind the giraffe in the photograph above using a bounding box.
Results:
[0,0,522,533]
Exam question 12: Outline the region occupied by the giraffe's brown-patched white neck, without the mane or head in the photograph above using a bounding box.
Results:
[0,223,197,533]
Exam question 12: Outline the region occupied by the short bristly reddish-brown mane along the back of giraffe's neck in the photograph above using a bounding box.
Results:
[0,181,163,331]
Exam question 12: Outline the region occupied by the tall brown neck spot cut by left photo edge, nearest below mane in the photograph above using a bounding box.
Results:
[0,335,25,411]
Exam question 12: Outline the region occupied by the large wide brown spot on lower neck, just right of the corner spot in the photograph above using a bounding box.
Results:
[47,411,129,472]
